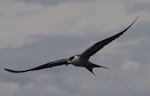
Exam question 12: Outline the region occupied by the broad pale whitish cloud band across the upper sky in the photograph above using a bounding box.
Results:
[0,0,147,47]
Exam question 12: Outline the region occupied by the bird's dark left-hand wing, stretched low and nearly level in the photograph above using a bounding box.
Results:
[5,59,68,73]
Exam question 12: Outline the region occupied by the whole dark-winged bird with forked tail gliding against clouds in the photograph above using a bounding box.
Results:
[4,16,139,75]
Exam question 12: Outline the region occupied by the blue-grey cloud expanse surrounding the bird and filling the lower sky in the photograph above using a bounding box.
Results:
[0,19,150,96]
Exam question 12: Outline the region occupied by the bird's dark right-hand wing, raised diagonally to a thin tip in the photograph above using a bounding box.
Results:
[80,17,138,59]
